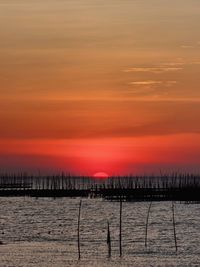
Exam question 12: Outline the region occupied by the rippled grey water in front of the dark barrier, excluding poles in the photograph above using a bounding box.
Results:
[0,197,200,267]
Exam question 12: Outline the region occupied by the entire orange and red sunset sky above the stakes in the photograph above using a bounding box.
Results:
[0,0,200,175]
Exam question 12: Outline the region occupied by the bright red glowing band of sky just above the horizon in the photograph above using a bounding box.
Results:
[0,134,200,176]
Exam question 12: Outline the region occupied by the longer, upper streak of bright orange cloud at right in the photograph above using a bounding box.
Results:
[124,67,183,73]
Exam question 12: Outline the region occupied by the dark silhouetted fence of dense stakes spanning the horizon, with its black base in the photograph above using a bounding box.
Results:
[0,173,200,202]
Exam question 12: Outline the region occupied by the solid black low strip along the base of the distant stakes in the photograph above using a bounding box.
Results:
[0,188,200,202]
